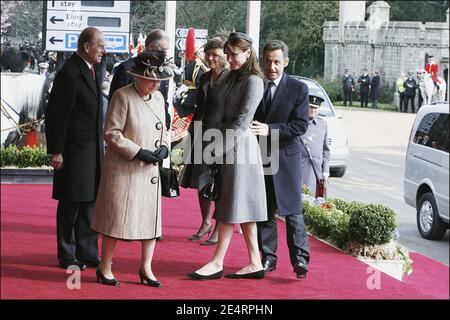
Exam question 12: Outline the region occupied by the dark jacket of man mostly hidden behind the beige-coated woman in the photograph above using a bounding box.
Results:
[109,59,171,130]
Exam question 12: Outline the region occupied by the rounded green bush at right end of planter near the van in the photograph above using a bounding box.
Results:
[349,204,396,245]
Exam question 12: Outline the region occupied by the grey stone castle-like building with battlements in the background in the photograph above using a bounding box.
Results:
[323,1,449,85]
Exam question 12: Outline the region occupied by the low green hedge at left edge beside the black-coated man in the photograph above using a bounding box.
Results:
[0,145,50,168]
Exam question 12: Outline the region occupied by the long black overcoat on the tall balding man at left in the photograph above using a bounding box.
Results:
[45,53,103,201]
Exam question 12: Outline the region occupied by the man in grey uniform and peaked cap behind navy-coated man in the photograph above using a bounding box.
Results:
[301,95,330,195]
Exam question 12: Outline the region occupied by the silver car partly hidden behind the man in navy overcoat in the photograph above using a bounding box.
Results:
[292,75,349,177]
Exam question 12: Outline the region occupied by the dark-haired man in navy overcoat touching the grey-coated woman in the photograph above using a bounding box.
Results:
[251,40,310,278]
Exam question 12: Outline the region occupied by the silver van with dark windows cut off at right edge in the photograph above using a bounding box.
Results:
[403,102,449,240]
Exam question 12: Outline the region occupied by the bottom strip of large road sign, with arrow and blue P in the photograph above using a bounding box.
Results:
[45,30,130,52]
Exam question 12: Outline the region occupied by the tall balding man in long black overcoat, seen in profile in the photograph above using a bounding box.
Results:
[45,27,106,270]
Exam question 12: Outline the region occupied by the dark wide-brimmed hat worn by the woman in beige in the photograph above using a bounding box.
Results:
[127,50,174,80]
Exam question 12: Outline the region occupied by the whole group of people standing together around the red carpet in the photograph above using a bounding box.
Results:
[45,27,329,287]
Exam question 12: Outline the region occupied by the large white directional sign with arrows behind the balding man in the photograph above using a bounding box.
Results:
[45,0,130,53]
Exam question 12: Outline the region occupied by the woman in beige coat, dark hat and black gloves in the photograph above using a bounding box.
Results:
[92,51,173,287]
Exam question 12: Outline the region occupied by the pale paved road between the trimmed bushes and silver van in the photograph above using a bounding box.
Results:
[329,109,449,265]
